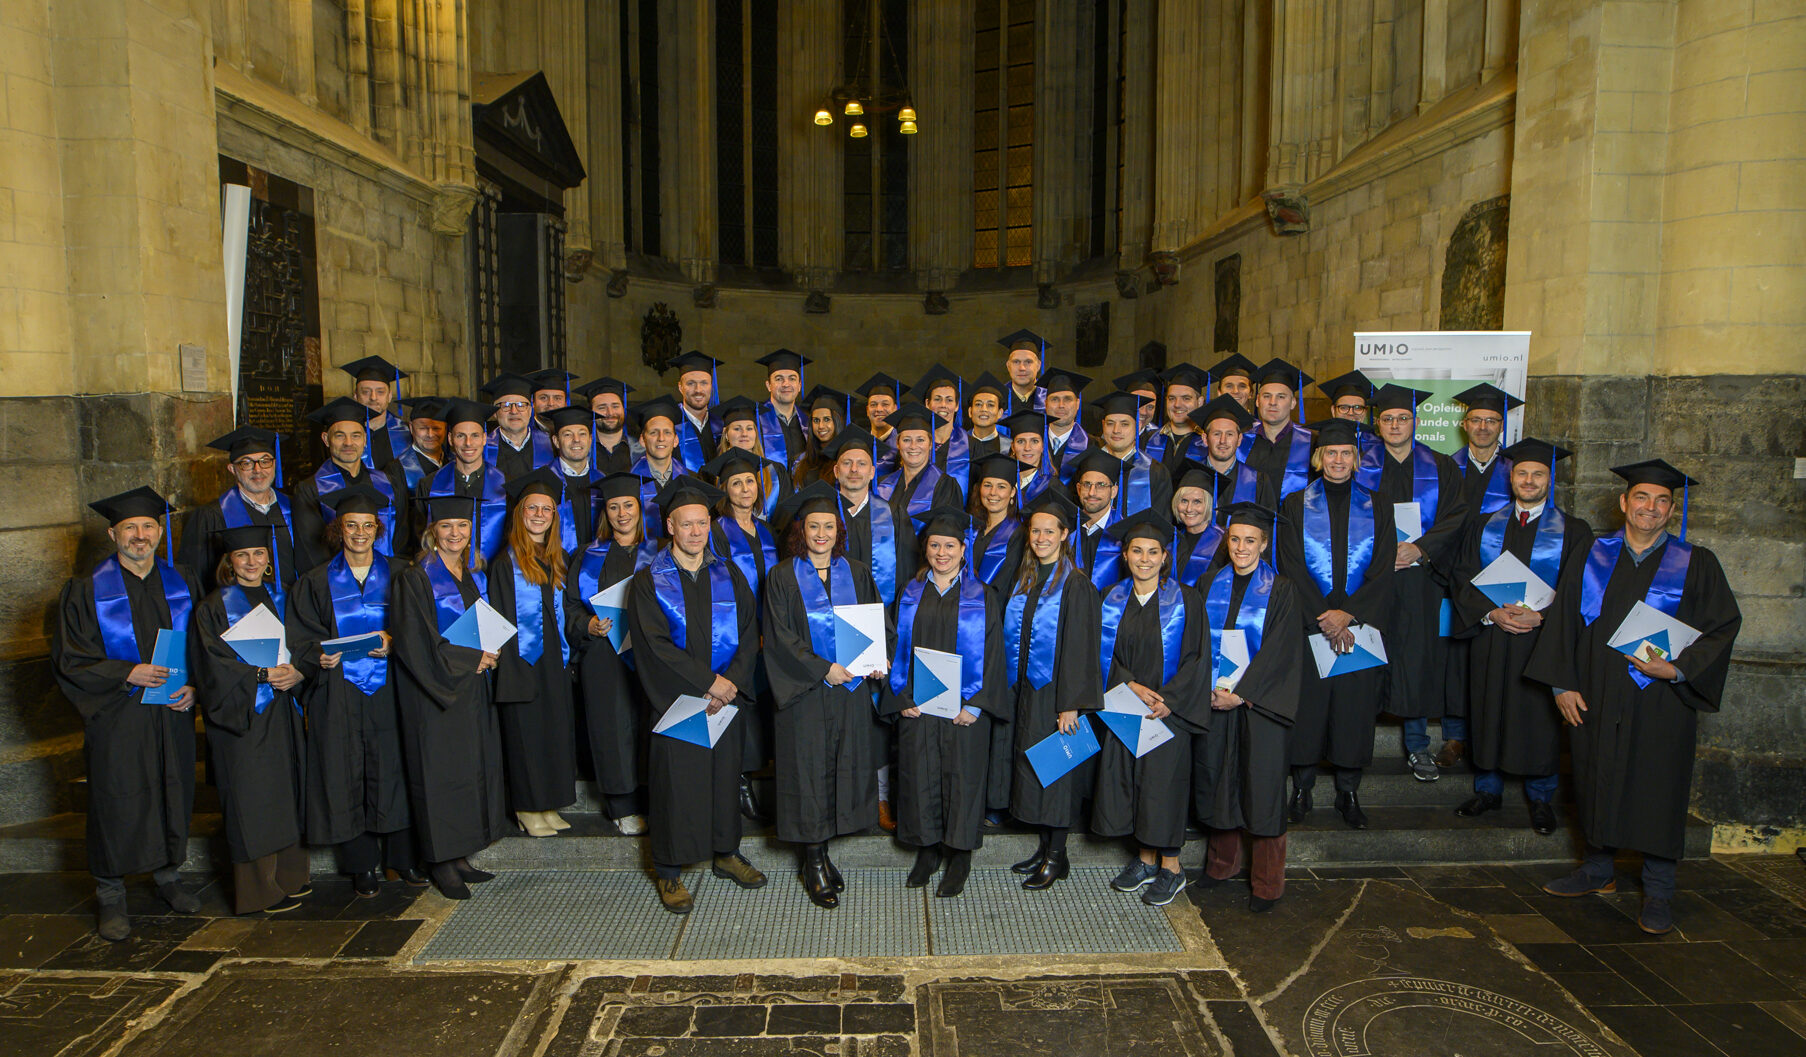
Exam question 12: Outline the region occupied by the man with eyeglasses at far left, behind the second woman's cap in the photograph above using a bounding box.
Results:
[177,426,298,591]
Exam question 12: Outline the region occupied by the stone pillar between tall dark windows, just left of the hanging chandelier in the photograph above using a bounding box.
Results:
[778,0,837,289]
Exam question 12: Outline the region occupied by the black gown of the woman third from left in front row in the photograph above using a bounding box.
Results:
[287,555,412,844]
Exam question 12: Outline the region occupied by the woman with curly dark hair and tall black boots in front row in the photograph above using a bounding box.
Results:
[764,481,890,909]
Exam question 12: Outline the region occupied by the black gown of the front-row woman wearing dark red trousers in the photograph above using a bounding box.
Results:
[1192,576,1311,837]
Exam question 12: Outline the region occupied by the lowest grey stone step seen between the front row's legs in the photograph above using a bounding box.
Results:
[0,804,1712,873]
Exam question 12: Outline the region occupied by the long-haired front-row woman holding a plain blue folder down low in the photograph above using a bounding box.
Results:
[1004,488,1103,889]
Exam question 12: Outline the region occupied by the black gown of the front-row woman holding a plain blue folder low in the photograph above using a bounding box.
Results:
[1006,558,1103,828]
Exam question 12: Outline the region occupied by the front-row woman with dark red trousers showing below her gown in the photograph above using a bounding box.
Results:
[1192,502,1311,914]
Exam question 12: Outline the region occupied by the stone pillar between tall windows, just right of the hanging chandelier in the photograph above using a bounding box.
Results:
[903,0,973,291]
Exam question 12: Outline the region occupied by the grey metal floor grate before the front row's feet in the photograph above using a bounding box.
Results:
[417,864,1183,961]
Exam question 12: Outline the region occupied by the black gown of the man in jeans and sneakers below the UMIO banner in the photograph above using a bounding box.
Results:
[1373,450,1466,719]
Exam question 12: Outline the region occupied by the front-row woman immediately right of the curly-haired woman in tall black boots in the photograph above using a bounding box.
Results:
[880,508,1015,898]
